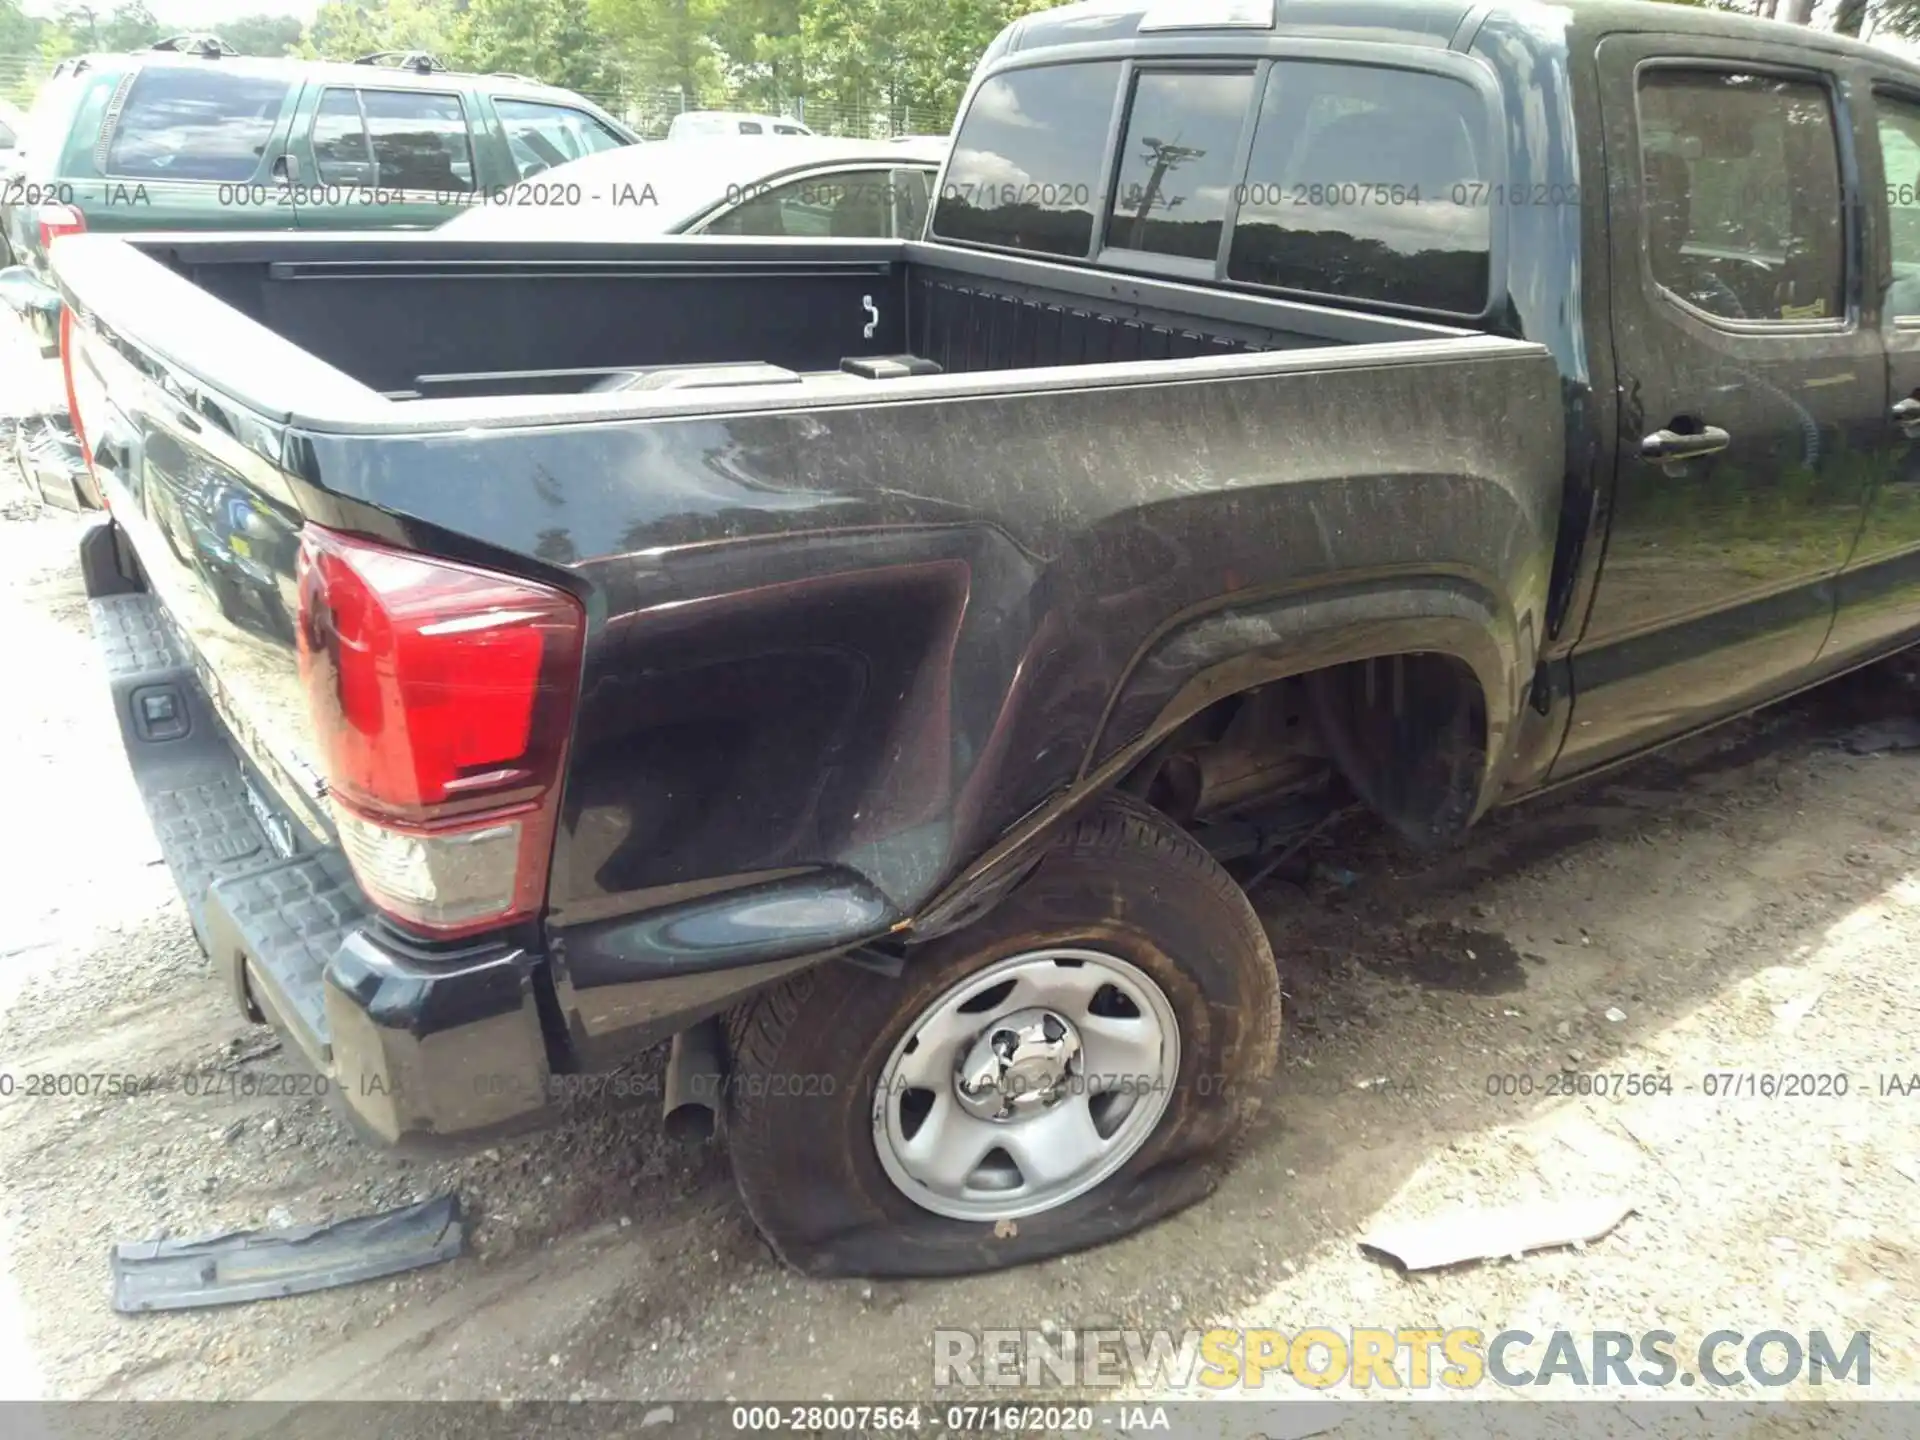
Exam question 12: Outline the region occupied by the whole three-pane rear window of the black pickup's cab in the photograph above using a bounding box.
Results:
[931,60,1501,315]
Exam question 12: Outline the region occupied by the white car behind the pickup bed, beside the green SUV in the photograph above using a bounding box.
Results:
[440,134,947,240]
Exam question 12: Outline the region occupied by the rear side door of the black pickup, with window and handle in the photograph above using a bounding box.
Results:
[1553,35,1885,778]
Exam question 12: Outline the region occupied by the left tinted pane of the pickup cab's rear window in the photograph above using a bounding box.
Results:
[933,61,1121,255]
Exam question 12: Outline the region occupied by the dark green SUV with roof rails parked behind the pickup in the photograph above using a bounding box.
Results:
[0,35,639,355]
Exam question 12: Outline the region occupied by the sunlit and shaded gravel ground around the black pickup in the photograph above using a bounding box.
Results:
[0,324,1920,1434]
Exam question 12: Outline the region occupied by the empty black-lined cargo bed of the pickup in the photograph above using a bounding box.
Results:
[61,234,1471,428]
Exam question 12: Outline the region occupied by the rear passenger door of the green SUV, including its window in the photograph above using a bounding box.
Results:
[294,84,476,230]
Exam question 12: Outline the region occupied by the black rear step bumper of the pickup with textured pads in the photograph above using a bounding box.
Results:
[83,568,553,1152]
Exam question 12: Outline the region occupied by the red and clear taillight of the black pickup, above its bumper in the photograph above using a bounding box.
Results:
[298,526,586,935]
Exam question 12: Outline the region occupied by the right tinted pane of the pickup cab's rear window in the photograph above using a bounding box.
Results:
[1227,61,1500,315]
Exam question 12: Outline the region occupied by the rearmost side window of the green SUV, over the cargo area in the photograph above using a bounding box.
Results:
[106,65,290,180]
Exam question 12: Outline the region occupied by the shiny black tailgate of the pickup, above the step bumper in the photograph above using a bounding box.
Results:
[56,236,371,856]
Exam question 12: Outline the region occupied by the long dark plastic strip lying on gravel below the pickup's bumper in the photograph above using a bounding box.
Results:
[113,1194,467,1315]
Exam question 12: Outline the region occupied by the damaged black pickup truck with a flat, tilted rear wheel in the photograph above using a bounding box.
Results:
[54,0,1920,1273]
